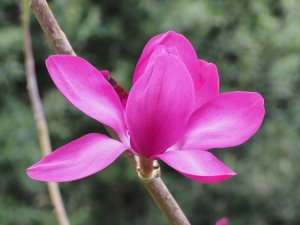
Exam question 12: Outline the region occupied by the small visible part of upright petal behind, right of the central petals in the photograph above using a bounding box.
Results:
[195,60,220,108]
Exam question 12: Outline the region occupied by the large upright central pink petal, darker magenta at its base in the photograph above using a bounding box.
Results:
[125,48,195,157]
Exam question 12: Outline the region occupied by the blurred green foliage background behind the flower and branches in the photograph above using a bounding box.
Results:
[0,0,300,225]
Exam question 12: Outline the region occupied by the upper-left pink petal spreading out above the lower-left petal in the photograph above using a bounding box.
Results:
[46,55,125,139]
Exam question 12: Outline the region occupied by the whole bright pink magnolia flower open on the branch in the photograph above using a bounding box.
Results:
[27,31,264,183]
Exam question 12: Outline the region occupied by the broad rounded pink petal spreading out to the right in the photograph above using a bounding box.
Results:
[176,92,265,150]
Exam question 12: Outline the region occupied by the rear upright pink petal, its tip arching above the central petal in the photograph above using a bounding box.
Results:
[133,31,198,82]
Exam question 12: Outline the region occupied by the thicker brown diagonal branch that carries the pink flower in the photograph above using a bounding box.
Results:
[30,0,190,225]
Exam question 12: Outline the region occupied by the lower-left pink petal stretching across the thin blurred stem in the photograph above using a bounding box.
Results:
[27,134,128,182]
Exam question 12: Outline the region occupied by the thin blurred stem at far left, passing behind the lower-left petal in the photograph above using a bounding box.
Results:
[22,0,70,225]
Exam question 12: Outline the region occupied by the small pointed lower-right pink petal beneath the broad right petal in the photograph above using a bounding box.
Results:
[156,150,236,183]
